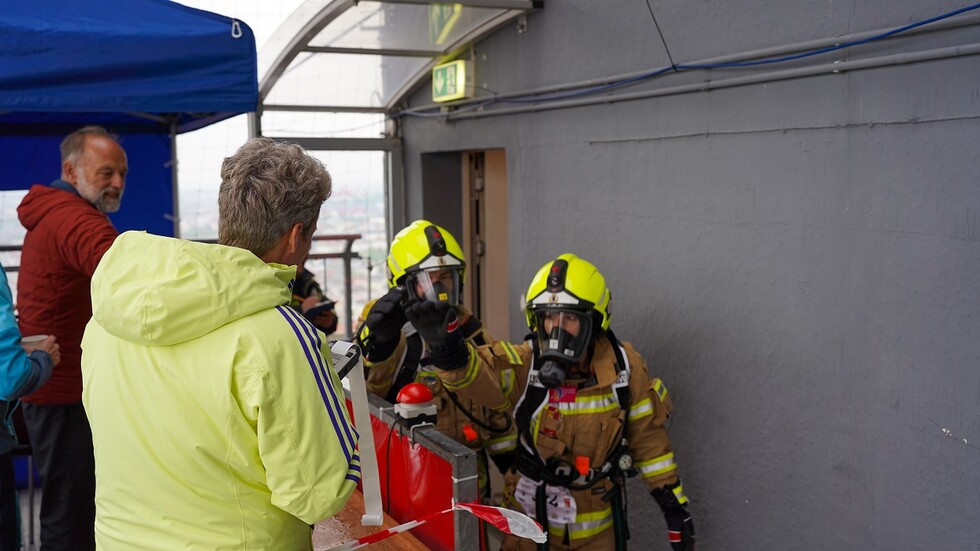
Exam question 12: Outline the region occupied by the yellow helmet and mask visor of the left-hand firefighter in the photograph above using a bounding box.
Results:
[385,220,466,306]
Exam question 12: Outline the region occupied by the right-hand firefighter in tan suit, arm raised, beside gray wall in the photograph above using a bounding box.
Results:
[415,254,694,551]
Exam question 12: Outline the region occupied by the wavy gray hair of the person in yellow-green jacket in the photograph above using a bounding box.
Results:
[218,138,331,256]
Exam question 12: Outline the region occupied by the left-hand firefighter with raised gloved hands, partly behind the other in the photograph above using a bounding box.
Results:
[357,220,517,498]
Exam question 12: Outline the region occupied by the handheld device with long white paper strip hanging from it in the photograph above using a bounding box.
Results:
[330,341,384,526]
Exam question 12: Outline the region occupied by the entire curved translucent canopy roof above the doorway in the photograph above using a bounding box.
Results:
[258,0,540,112]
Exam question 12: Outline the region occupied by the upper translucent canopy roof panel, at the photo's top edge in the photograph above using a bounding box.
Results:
[310,0,506,54]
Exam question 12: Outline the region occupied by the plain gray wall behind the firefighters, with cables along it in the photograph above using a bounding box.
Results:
[403,0,980,551]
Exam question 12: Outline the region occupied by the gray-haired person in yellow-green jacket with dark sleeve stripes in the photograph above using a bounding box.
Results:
[82,138,360,551]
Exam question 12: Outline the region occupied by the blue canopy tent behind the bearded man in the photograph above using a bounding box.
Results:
[0,0,258,235]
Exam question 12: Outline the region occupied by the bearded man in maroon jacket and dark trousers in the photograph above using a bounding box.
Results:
[17,126,128,551]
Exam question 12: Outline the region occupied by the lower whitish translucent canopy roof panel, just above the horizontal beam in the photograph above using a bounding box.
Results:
[265,53,431,107]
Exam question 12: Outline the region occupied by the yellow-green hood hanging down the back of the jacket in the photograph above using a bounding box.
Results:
[92,232,296,346]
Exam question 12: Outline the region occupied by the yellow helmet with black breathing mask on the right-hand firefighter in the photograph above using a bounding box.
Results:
[524,253,612,362]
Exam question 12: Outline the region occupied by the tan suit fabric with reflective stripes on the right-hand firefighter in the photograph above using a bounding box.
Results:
[439,338,678,538]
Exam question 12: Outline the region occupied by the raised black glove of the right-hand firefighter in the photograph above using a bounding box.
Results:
[405,300,470,371]
